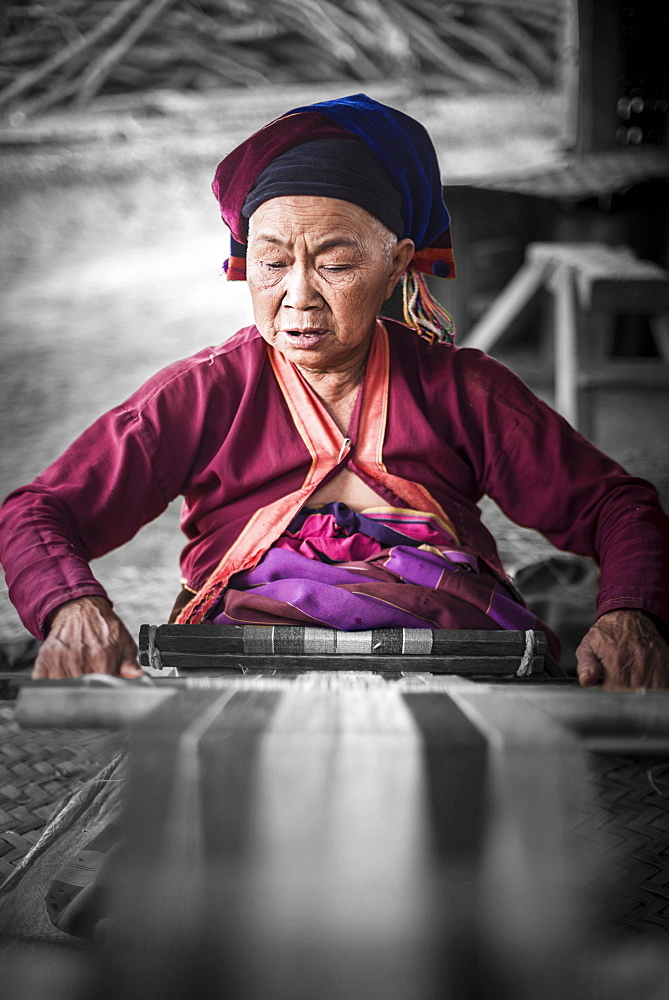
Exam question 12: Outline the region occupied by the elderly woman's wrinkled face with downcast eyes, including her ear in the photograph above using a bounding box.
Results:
[246,195,414,372]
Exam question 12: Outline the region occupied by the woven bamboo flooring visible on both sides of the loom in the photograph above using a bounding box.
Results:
[0,688,669,933]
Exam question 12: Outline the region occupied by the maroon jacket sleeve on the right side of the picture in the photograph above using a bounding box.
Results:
[462,350,669,624]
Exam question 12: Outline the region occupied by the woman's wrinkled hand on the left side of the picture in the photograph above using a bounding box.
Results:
[32,597,144,680]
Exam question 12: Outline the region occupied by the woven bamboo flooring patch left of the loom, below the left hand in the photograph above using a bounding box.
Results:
[0,702,118,881]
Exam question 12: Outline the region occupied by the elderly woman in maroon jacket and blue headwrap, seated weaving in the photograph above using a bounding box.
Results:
[2,95,669,687]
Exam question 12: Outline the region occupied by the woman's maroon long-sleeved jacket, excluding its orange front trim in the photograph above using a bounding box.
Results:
[0,320,669,637]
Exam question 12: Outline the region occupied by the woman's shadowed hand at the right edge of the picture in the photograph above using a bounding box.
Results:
[576,608,669,690]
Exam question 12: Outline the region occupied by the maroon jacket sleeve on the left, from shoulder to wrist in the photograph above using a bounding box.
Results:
[0,327,258,638]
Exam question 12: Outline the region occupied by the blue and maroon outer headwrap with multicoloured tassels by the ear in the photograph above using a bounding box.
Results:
[212,94,455,342]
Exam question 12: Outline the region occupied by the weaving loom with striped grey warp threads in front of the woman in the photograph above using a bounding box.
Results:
[1,626,669,1000]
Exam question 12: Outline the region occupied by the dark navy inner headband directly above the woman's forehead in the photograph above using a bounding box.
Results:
[242,138,404,239]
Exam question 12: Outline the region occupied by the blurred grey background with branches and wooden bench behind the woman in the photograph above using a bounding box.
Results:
[0,0,669,648]
